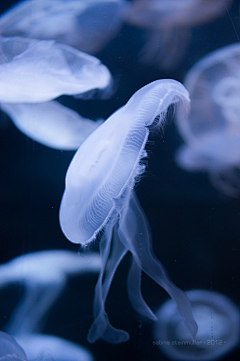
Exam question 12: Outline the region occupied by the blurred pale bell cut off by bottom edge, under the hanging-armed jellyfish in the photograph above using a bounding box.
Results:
[16,334,94,361]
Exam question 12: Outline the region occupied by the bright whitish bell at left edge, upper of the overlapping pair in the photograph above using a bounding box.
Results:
[0,37,111,103]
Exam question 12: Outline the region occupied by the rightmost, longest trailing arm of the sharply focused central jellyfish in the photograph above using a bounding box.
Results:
[118,192,198,339]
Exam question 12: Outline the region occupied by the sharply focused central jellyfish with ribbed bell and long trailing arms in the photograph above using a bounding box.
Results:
[59,80,197,343]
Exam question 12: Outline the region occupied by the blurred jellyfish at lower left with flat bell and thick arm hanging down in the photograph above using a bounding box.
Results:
[0,250,101,335]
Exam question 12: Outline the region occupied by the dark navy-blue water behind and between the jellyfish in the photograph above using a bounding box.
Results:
[0,0,240,361]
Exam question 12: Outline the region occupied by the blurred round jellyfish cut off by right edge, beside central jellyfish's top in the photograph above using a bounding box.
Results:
[176,44,240,196]
